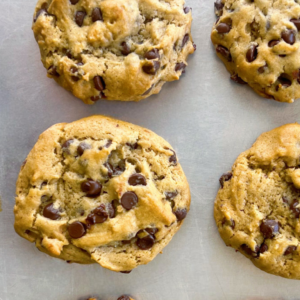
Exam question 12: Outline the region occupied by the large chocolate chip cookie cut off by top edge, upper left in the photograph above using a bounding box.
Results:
[32,0,194,104]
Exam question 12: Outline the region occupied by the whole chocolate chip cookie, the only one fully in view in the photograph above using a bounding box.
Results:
[15,116,190,273]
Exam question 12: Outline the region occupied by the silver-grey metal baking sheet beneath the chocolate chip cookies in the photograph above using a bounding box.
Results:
[0,0,300,300]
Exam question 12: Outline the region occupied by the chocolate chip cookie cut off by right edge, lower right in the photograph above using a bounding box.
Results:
[214,123,300,279]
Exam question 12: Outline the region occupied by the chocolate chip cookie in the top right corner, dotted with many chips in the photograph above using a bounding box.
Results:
[211,0,300,103]
